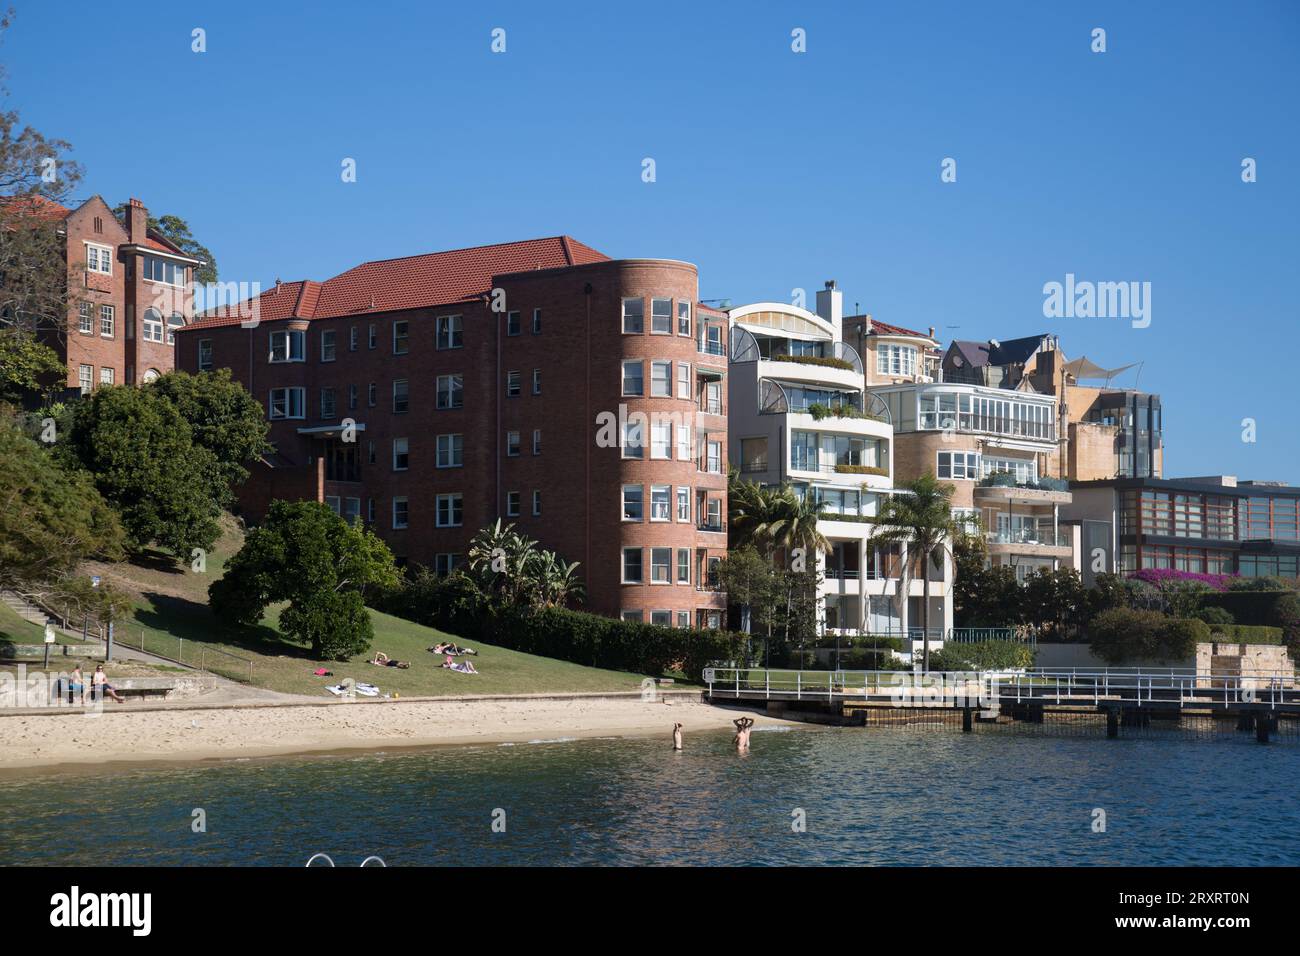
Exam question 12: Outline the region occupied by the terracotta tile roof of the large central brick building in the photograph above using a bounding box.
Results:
[189,235,608,328]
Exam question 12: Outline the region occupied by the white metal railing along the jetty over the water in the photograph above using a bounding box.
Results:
[705,667,1300,713]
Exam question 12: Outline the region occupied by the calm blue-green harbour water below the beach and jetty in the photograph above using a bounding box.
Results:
[0,727,1300,866]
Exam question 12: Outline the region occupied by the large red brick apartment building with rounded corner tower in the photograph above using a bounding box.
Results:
[176,237,727,627]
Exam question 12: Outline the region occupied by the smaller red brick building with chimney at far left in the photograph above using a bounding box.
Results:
[4,196,202,393]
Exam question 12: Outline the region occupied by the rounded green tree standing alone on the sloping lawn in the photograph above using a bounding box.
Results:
[208,501,398,661]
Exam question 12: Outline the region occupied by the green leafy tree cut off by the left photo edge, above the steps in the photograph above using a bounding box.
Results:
[0,418,124,597]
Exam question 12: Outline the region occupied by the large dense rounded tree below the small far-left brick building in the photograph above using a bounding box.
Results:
[59,385,221,559]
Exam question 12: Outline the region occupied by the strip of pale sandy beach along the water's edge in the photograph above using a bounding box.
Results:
[0,695,789,770]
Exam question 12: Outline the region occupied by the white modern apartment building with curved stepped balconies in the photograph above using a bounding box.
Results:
[727,282,953,639]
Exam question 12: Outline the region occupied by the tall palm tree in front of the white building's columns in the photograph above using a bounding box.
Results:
[872,471,962,671]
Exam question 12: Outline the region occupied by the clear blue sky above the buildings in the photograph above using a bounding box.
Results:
[0,0,1300,483]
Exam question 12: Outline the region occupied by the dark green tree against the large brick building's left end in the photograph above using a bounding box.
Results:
[146,368,272,507]
